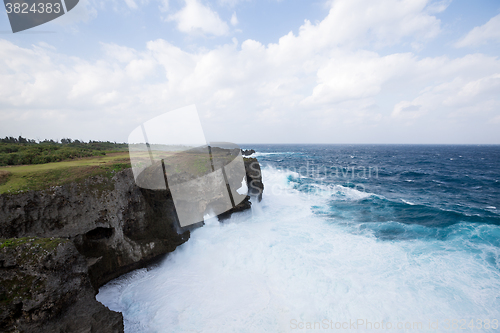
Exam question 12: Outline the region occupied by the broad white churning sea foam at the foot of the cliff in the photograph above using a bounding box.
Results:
[97,169,500,332]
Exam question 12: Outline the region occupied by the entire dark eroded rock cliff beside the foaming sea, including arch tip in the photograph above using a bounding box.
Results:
[0,158,264,332]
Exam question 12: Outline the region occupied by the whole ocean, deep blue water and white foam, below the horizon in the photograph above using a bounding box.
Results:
[97,145,500,332]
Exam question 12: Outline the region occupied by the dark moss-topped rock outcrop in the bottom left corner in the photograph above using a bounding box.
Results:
[0,237,123,333]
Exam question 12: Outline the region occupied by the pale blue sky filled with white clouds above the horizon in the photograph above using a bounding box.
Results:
[0,0,500,144]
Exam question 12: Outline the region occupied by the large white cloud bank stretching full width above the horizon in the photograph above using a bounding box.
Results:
[0,0,500,143]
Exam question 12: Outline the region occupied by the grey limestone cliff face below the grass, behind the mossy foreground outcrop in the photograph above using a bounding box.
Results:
[0,169,189,290]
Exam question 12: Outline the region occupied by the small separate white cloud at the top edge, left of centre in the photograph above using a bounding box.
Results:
[168,0,229,36]
